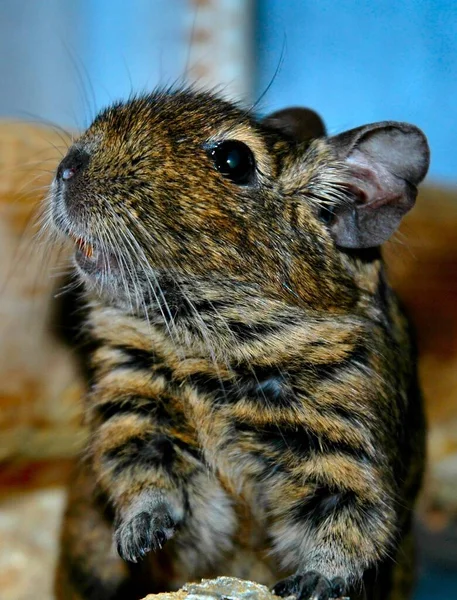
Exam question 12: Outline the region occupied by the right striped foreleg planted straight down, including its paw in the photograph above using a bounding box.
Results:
[230,408,398,600]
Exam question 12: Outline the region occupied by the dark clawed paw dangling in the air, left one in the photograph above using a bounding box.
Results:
[114,504,177,563]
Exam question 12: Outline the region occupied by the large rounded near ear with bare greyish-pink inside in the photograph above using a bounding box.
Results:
[328,121,430,248]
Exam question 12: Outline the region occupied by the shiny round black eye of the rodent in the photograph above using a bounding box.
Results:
[209,140,255,185]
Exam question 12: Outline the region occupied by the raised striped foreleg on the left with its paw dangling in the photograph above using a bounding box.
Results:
[91,394,202,562]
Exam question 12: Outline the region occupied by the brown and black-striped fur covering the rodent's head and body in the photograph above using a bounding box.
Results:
[52,91,424,600]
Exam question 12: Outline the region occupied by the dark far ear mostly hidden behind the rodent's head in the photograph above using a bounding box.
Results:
[262,107,326,142]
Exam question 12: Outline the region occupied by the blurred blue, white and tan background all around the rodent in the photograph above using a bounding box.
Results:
[0,0,457,600]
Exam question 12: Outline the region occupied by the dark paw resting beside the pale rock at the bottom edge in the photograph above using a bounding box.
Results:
[273,571,349,600]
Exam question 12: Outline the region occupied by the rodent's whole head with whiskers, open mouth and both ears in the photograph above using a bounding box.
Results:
[51,91,429,318]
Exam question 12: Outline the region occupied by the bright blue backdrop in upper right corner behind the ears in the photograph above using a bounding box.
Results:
[257,0,457,183]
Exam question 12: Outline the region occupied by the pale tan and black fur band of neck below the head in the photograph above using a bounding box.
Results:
[85,288,374,368]
